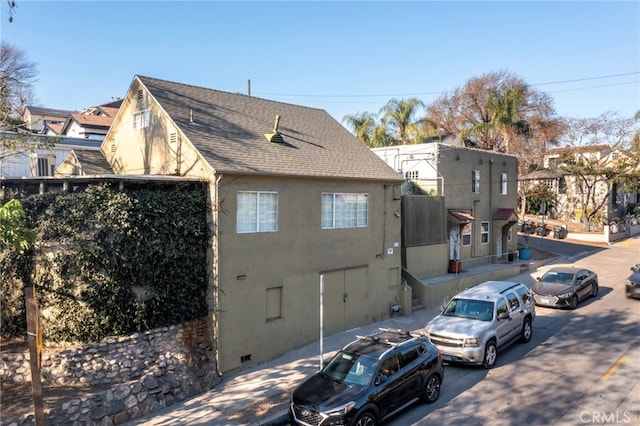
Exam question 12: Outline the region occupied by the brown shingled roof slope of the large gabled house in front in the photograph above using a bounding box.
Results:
[134,76,402,182]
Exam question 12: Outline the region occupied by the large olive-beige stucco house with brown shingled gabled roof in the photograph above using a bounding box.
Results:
[101,76,402,371]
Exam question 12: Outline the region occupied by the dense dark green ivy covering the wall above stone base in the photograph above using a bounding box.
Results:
[0,183,210,342]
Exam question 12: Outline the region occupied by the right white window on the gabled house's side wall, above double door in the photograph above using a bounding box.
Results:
[322,193,369,229]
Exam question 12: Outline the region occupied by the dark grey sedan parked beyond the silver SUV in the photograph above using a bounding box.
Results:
[531,266,598,309]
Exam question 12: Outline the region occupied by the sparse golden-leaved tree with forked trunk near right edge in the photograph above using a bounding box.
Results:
[562,112,640,231]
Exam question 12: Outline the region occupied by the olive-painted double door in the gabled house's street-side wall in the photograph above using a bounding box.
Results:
[323,268,368,336]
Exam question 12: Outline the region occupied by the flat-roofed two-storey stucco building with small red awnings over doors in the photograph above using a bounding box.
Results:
[373,143,518,279]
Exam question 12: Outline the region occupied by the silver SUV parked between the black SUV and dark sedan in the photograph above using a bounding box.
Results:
[425,281,536,368]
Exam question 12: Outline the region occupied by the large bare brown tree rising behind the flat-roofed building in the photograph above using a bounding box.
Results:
[427,71,564,171]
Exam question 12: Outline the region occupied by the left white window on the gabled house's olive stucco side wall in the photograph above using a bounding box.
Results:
[236,191,278,234]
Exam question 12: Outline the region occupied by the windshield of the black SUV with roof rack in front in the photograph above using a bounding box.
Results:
[322,351,376,385]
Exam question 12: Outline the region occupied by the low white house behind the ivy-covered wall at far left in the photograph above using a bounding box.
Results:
[0,132,104,177]
